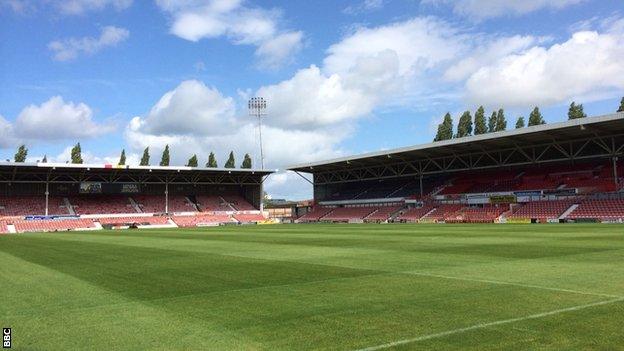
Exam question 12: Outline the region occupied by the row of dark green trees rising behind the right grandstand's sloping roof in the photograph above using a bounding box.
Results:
[433,97,624,141]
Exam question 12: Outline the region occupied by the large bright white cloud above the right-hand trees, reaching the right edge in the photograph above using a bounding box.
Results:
[466,22,624,107]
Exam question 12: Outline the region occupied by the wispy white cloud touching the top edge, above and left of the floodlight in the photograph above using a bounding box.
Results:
[156,0,303,67]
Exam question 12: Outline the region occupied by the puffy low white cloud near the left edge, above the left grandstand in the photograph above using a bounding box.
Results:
[13,96,114,140]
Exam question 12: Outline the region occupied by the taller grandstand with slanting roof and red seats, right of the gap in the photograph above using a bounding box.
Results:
[288,113,624,223]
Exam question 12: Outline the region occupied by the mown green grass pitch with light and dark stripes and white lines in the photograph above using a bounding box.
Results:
[0,224,624,350]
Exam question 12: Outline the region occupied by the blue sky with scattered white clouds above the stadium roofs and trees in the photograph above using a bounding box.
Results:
[0,0,624,198]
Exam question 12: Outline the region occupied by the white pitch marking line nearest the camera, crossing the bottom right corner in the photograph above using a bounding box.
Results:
[356,297,624,351]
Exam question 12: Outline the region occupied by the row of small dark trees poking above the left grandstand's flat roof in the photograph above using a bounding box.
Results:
[14,143,252,169]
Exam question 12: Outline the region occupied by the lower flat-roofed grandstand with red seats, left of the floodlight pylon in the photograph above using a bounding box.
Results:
[0,162,271,233]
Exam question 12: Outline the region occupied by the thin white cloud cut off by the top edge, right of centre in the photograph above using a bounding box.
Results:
[424,0,585,20]
